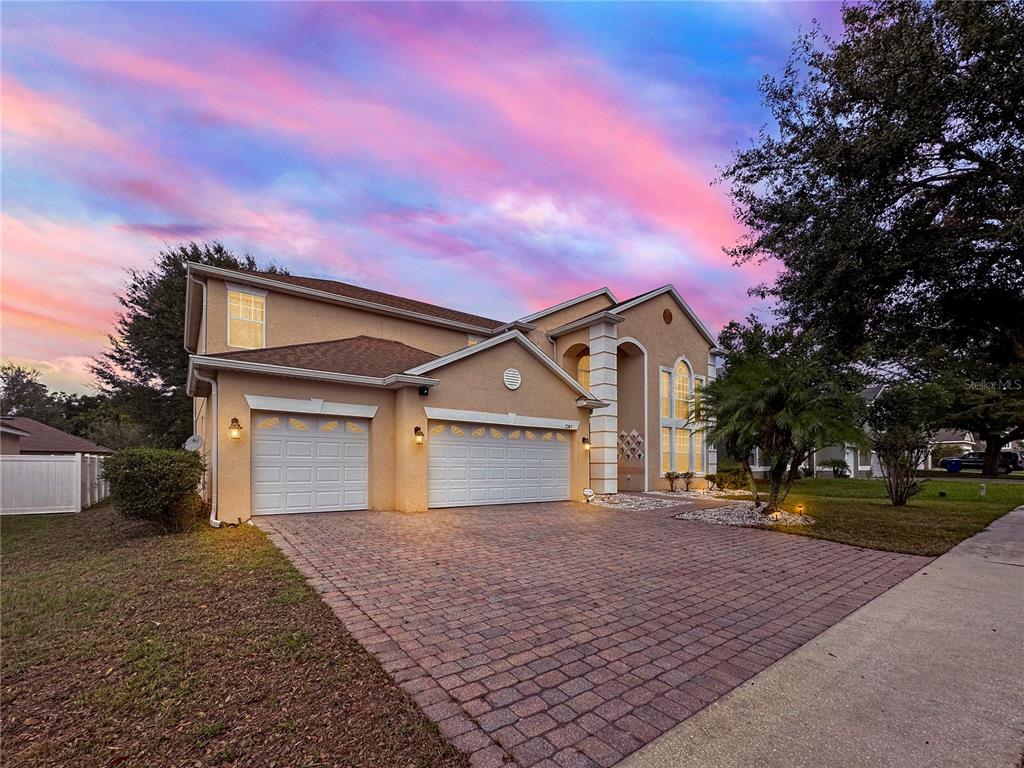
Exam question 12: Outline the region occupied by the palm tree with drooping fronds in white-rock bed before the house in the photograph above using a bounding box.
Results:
[700,352,861,515]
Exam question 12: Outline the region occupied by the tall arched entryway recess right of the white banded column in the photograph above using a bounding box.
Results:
[616,338,648,490]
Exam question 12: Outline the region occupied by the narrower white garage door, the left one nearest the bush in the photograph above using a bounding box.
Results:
[252,412,370,515]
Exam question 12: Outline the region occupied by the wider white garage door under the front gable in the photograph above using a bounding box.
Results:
[428,422,571,507]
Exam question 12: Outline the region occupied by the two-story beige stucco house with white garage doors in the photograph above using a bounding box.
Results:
[184,264,717,522]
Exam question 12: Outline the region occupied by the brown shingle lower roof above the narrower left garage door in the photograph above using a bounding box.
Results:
[209,336,437,377]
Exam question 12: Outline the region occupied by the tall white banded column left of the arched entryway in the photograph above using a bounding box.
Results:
[590,323,618,494]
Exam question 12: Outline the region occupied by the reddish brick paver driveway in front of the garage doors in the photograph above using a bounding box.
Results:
[258,503,928,768]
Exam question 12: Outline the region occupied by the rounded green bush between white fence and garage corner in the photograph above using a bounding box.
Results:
[103,449,206,531]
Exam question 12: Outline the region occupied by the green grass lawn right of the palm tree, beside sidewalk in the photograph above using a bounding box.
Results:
[737,478,1024,555]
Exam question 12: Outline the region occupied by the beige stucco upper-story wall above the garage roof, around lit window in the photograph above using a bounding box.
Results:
[206,278,469,354]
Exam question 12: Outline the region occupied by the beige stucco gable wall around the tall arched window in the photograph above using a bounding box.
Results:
[617,294,711,489]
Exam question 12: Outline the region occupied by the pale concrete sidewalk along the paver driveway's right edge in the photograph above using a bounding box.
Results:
[620,507,1024,768]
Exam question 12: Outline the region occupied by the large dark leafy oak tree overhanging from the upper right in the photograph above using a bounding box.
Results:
[724,0,1024,472]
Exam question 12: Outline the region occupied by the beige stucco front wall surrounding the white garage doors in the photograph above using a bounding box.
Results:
[200,342,590,522]
